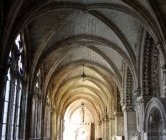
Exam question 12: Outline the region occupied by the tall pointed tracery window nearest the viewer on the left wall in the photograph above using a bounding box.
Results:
[1,34,25,140]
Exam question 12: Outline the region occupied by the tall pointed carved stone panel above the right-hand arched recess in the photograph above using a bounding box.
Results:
[143,32,160,97]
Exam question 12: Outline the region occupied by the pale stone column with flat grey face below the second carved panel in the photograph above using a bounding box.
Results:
[122,105,136,140]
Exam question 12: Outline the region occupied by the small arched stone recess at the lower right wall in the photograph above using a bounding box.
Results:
[144,98,166,140]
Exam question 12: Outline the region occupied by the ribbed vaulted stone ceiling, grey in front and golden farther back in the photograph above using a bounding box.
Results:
[1,0,165,120]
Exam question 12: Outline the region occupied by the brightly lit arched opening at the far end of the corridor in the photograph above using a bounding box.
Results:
[63,99,96,140]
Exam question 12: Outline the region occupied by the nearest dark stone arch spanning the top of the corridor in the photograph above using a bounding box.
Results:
[2,1,165,67]
